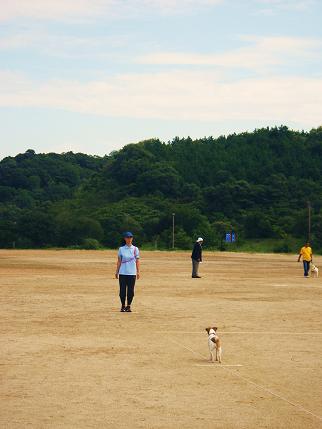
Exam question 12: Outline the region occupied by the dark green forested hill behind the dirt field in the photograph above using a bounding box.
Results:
[0,127,322,249]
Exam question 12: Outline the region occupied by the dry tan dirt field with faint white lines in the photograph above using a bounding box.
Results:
[0,250,322,429]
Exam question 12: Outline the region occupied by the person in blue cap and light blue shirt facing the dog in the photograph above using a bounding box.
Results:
[115,231,140,313]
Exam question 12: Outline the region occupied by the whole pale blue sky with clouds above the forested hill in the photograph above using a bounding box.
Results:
[0,0,322,159]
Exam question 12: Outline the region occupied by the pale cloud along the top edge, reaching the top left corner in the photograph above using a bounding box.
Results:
[0,0,223,21]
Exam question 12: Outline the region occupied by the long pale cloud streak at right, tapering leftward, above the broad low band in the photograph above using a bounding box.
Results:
[137,37,322,70]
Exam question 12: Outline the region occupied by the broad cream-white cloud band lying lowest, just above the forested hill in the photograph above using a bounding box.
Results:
[0,71,322,127]
